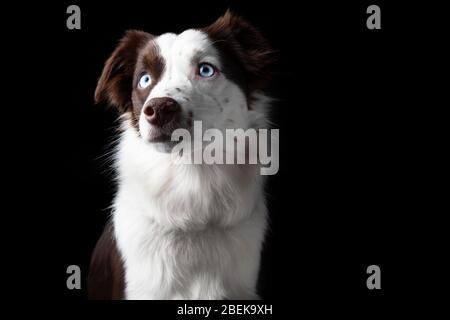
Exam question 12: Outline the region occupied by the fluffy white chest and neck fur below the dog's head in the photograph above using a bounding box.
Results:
[114,130,266,299]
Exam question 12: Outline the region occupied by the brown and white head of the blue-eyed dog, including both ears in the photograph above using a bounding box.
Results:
[95,11,273,149]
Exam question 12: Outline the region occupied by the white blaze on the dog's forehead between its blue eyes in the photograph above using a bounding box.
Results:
[147,29,221,101]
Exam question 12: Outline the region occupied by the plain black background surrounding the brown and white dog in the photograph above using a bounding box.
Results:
[4,0,446,314]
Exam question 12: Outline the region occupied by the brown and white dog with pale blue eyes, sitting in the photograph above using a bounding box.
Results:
[88,12,273,299]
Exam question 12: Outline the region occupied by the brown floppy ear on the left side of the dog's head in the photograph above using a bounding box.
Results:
[95,30,153,113]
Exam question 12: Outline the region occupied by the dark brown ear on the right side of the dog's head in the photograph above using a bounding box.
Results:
[203,10,275,90]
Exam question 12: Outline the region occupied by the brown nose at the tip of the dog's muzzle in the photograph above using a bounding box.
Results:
[144,97,181,126]
